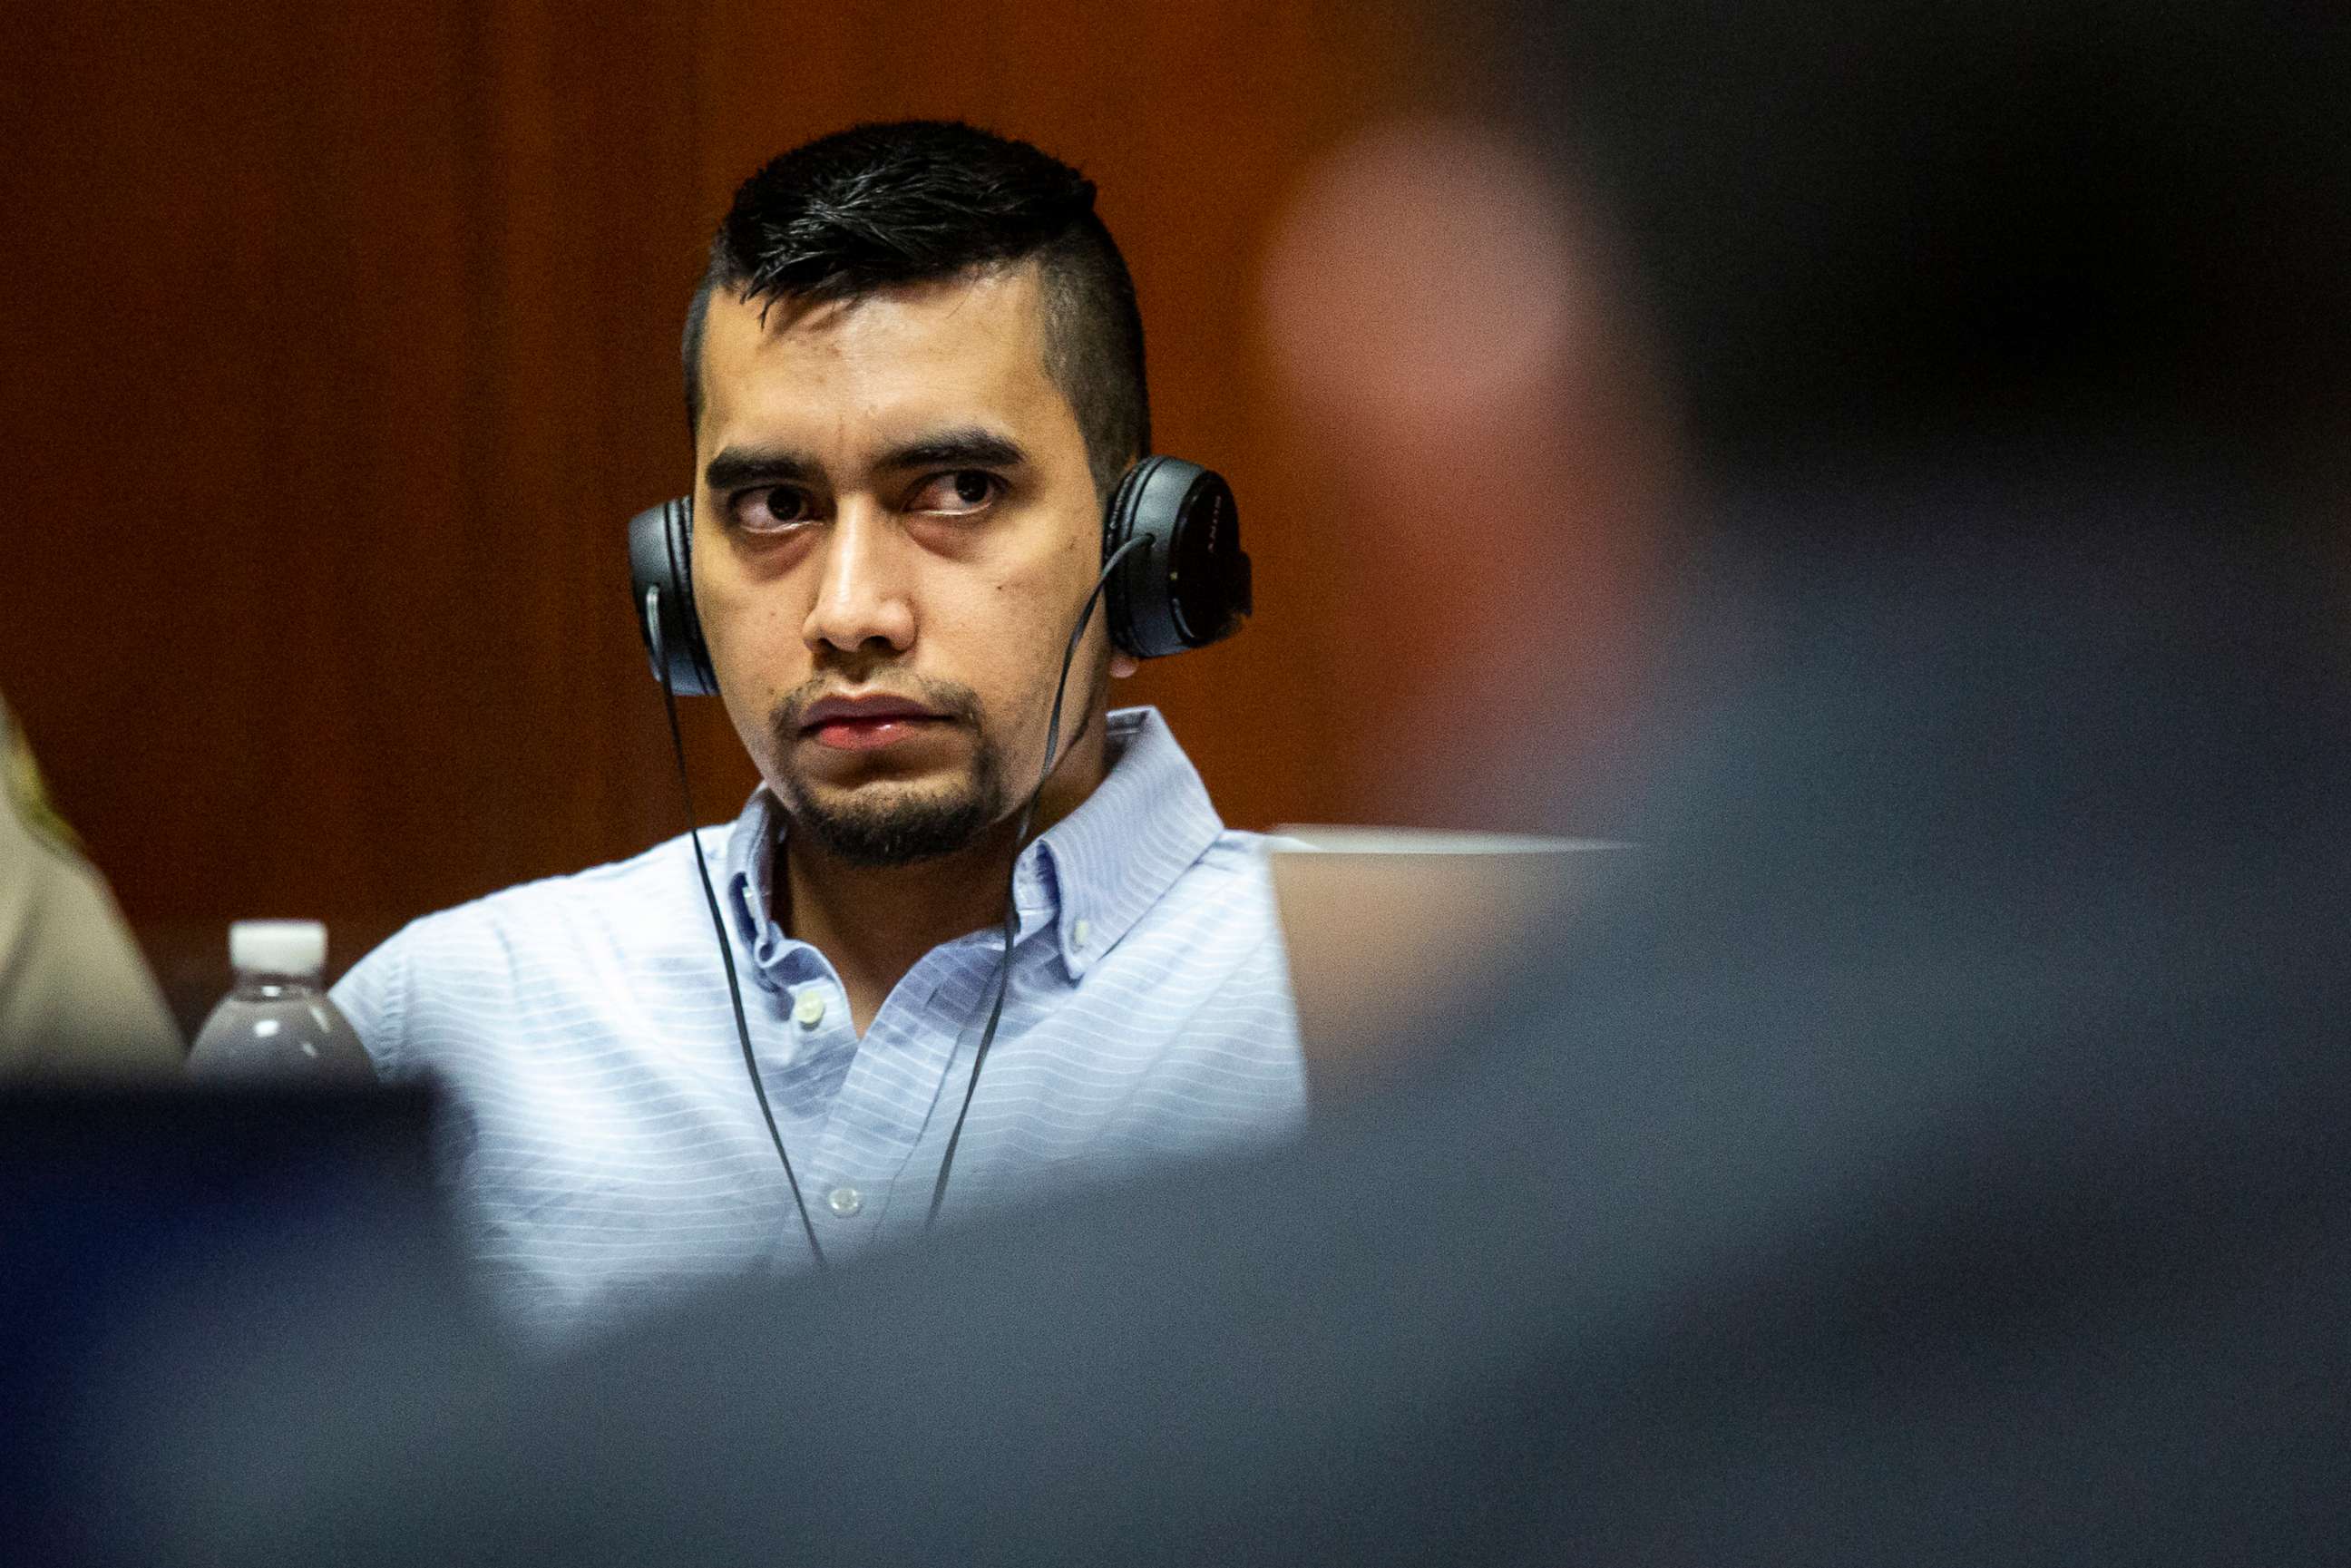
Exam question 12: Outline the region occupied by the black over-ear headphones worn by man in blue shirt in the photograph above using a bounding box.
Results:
[628,456,1251,696]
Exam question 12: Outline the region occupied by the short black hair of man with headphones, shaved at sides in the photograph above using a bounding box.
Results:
[684,120,1152,493]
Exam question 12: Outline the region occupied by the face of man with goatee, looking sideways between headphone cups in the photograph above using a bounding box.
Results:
[694,268,1131,865]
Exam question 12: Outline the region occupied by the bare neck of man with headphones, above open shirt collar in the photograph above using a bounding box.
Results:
[774,715,1109,1035]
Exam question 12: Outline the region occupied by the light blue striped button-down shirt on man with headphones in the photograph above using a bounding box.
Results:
[334,707,1305,1330]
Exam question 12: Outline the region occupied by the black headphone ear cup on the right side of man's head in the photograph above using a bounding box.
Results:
[1103,456,1254,658]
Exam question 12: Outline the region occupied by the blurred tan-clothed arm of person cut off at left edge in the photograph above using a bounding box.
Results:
[0,703,183,1084]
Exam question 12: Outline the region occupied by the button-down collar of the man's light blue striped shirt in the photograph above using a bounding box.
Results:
[727,707,1224,980]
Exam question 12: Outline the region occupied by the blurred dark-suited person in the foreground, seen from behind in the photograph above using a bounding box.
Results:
[68,3,2351,1563]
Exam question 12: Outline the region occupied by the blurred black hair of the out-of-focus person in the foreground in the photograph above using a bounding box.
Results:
[1514,0,2351,479]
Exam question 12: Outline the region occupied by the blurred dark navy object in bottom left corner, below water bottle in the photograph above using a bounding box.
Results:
[0,1086,473,1563]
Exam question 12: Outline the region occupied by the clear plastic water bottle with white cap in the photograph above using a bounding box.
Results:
[188,920,376,1081]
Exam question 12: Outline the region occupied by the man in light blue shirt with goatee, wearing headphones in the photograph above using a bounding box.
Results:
[334,122,1302,1329]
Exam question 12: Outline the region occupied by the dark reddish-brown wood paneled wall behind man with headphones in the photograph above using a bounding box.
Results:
[0,0,1422,1020]
